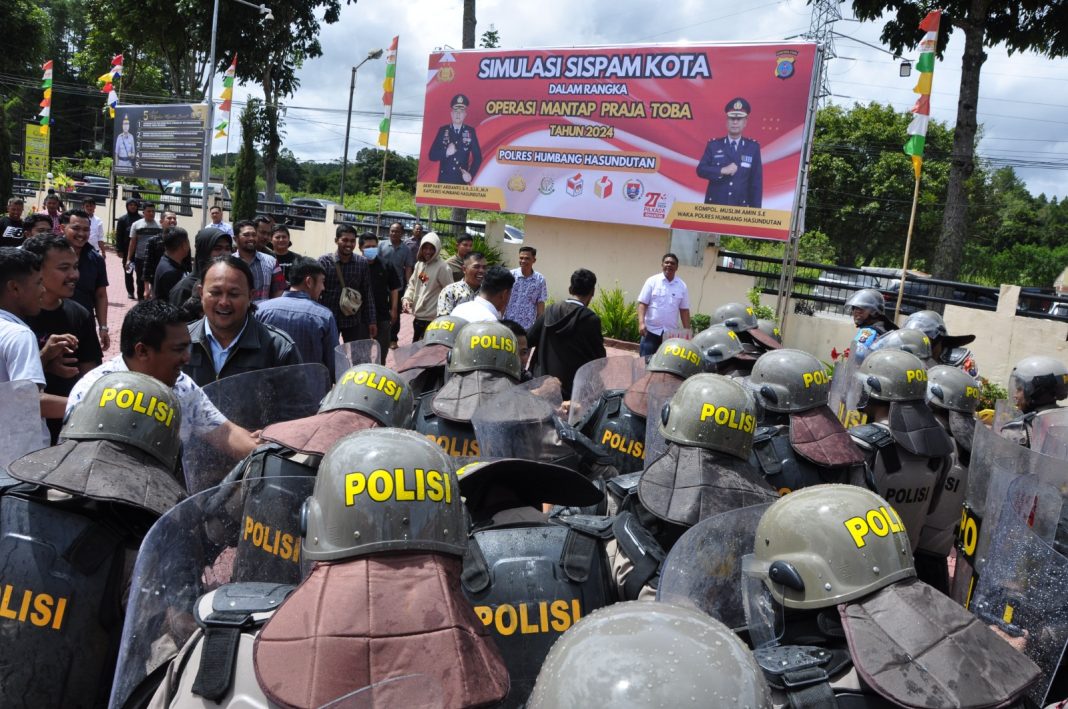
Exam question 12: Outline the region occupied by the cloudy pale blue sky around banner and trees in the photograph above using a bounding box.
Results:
[214,0,1068,199]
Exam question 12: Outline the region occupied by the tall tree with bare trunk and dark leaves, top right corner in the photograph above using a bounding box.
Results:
[852,0,1068,279]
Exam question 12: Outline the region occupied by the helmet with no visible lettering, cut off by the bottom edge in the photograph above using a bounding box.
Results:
[527,601,772,709]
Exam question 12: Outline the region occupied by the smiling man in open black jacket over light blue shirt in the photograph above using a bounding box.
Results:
[182,256,301,387]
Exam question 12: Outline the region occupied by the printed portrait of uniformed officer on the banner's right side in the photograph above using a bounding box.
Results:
[697,97,764,207]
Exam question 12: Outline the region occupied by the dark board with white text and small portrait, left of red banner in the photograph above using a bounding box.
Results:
[112,104,207,180]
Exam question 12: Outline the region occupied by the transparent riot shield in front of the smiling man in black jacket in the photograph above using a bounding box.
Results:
[182,364,330,493]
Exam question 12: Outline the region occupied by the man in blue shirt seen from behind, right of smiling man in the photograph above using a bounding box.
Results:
[253,256,335,379]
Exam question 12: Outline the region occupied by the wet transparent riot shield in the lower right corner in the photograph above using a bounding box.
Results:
[972,475,1068,707]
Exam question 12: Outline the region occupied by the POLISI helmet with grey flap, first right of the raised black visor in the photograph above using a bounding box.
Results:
[659,374,756,460]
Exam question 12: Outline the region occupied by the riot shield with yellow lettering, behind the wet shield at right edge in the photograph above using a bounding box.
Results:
[951,422,1068,608]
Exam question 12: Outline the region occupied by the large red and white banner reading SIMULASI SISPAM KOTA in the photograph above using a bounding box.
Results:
[415,43,816,239]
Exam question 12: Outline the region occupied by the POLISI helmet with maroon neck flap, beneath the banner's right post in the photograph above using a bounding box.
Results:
[749,349,831,413]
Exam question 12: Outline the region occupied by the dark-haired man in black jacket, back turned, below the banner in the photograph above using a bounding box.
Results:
[527,268,606,399]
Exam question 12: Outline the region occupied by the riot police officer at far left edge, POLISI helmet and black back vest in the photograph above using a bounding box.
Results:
[0,372,185,707]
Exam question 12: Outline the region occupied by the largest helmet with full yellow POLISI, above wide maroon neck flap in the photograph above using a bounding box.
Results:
[300,428,467,562]
